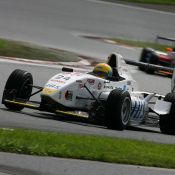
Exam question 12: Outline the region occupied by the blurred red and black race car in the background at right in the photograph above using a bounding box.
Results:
[139,48,175,76]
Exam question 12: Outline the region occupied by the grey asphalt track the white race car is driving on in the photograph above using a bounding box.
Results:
[0,60,175,143]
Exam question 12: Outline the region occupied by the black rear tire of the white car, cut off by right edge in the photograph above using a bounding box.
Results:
[160,93,175,135]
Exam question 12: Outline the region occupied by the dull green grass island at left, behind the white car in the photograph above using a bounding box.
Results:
[0,39,79,62]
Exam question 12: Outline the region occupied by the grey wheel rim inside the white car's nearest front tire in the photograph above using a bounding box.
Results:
[121,97,131,125]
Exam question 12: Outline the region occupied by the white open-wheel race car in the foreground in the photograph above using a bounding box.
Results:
[2,54,175,134]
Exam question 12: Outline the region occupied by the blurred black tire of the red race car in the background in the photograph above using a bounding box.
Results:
[139,48,159,74]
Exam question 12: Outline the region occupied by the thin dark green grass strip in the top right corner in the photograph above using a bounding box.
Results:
[106,0,175,5]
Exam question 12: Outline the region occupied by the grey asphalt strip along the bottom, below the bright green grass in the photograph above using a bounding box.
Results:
[0,152,175,175]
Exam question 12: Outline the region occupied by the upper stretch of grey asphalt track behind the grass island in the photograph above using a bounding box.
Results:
[0,0,175,58]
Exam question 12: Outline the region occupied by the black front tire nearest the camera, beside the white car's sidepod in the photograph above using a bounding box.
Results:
[105,89,131,130]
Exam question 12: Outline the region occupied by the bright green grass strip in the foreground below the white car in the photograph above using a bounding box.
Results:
[0,129,175,168]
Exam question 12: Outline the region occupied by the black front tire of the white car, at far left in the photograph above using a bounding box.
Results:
[2,69,33,111]
